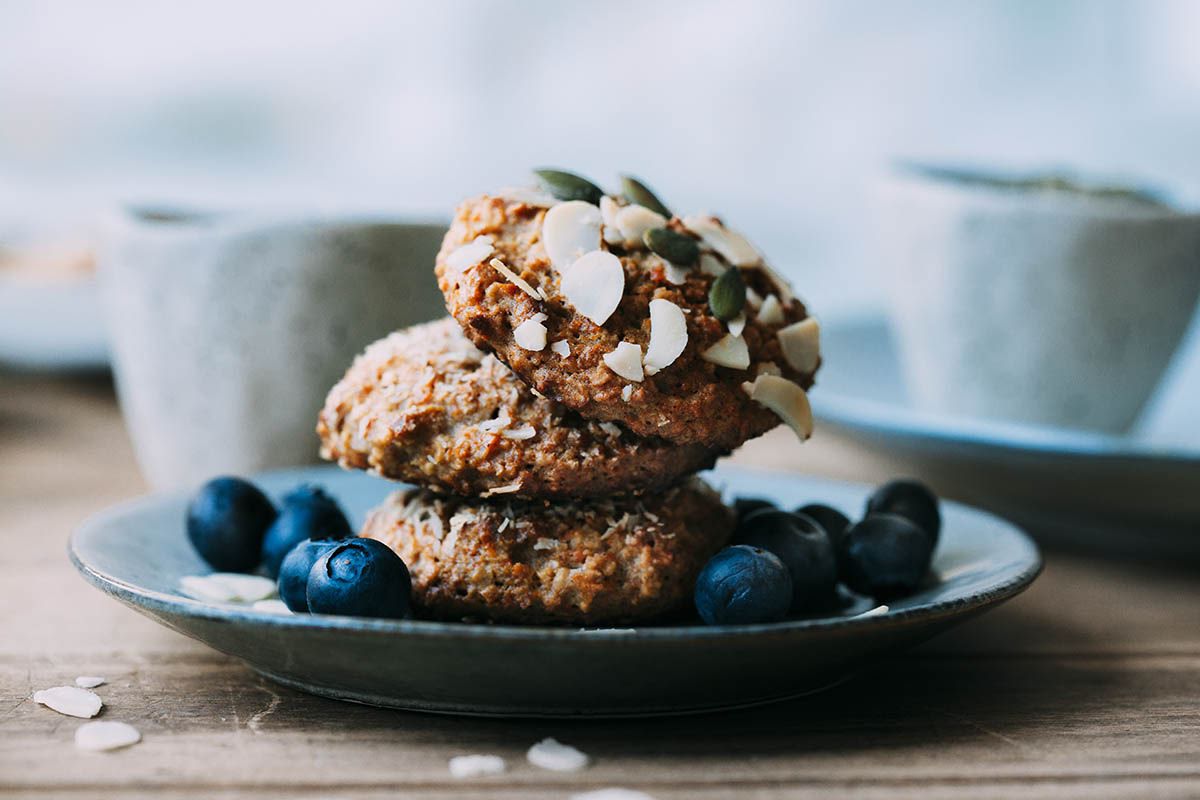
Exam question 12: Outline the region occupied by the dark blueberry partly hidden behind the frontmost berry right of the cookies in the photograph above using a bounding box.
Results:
[734,510,838,612]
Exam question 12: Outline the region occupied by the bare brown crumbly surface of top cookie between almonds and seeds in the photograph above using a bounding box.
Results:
[437,193,820,451]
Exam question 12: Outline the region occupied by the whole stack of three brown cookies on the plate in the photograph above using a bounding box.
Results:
[318,170,820,625]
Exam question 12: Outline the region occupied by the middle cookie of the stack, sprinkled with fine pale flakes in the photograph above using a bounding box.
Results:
[317,318,716,499]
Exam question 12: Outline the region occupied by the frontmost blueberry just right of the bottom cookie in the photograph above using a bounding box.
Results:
[696,545,792,625]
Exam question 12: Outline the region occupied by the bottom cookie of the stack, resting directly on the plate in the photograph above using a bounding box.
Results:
[362,479,734,625]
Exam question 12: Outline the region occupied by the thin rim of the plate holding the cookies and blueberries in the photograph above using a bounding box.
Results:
[67,464,1044,644]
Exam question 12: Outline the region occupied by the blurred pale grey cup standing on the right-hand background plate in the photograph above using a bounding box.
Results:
[876,165,1200,433]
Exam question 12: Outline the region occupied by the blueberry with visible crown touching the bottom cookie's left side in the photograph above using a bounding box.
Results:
[306,539,413,619]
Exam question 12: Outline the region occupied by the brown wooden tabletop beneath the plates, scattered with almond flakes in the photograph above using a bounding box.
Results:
[0,372,1200,799]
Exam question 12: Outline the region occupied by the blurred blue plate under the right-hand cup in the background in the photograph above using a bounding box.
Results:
[812,317,1200,558]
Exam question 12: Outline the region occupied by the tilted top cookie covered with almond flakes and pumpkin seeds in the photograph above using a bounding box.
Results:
[437,174,821,450]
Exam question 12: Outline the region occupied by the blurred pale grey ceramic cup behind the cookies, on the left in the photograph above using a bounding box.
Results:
[100,210,445,488]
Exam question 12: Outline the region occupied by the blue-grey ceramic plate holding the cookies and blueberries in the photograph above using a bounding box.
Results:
[71,467,1042,716]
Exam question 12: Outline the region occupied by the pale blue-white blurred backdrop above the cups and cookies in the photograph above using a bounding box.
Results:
[7,0,1200,315]
